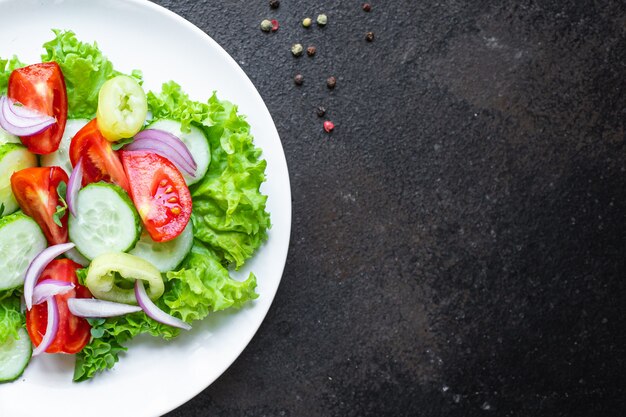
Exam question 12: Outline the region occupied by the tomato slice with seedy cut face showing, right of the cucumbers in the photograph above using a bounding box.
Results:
[121,151,191,242]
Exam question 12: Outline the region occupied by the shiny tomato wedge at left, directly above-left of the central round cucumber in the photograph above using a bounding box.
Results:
[11,167,68,245]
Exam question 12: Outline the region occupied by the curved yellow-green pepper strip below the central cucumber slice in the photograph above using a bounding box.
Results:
[85,252,164,304]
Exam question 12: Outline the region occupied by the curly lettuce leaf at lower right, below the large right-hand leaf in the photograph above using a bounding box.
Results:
[162,241,258,323]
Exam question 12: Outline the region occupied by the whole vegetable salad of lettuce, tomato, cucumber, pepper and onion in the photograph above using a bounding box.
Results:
[0,30,270,382]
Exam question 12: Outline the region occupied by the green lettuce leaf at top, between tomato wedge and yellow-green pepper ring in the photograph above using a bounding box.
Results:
[41,29,120,119]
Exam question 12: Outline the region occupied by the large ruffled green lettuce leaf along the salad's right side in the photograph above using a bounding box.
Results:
[148,82,270,268]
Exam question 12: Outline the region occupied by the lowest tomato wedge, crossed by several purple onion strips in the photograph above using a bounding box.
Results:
[26,259,91,353]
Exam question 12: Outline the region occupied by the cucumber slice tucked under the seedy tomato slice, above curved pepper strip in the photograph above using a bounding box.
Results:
[128,221,193,272]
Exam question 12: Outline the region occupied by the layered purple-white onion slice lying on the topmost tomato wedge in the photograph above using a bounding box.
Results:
[0,96,56,136]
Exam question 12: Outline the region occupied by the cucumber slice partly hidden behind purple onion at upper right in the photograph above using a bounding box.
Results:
[148,119,211,185]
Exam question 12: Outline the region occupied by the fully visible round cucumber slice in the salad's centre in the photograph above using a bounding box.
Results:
[68,182,141,260]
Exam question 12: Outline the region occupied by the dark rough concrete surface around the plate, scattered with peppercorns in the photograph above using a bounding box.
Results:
[158,0,626,417]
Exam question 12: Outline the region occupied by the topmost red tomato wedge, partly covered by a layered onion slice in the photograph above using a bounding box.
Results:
[7,62,67,154]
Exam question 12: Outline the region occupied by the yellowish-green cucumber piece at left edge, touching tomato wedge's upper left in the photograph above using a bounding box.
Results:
[0,143,37,216]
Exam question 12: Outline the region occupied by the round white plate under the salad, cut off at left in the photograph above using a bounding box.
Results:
[0,0,291,417]
